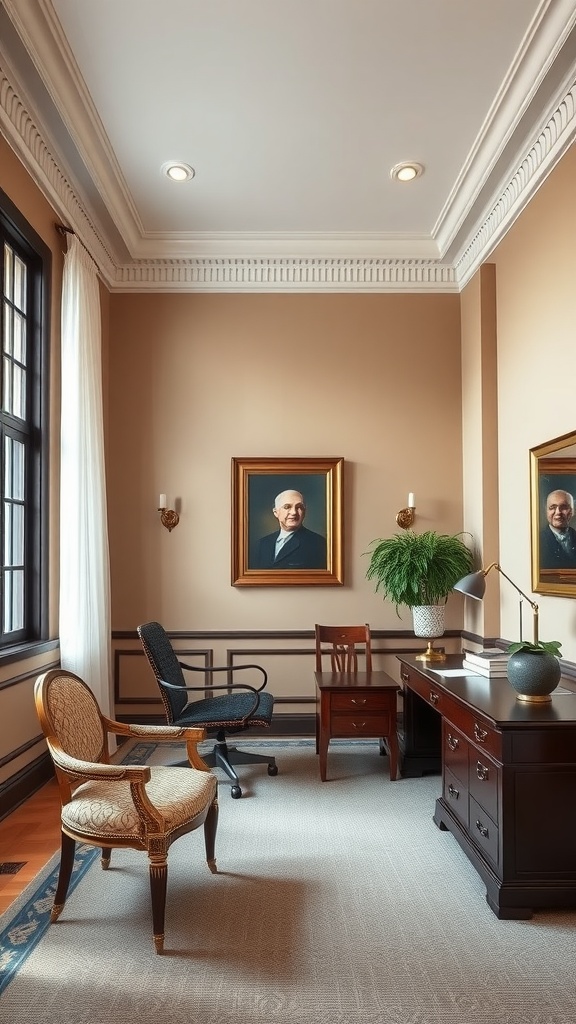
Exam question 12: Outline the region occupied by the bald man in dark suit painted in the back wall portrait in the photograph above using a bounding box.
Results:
[251,489,326,569]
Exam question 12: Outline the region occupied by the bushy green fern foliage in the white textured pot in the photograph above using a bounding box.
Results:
[365,529,474,614]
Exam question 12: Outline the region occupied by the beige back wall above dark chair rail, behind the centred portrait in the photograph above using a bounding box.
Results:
[110,295,462,630]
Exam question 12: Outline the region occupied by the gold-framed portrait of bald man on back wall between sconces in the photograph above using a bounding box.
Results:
[232,458,344,587]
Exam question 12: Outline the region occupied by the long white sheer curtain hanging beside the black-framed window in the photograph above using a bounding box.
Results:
[59,234,112,715]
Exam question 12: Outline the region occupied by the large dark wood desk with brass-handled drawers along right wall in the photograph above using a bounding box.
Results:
[399,654,576,920]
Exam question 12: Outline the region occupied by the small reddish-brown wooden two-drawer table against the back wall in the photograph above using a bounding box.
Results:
[314,672,400,782]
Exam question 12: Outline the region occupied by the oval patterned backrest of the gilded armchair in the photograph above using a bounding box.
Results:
[34,669,108,762]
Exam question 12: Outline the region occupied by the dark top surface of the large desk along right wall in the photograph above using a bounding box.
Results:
[397,654,576,728]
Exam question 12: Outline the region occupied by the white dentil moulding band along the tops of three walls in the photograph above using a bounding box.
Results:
[0,50,576,292]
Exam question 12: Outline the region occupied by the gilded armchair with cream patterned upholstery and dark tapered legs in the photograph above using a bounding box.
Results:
[34,669,218,953]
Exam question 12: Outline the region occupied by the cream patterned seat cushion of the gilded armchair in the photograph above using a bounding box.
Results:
[61,765,217,847]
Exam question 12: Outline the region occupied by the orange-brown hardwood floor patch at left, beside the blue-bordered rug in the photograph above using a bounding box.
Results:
[0,779,60,913]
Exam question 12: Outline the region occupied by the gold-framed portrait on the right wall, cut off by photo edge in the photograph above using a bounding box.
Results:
[530,434,576,597]
